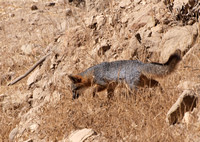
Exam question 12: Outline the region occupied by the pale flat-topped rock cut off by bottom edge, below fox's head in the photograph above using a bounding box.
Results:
[68,128,96,142]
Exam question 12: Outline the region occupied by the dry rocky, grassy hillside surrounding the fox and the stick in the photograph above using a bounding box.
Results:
[0,0,200,142]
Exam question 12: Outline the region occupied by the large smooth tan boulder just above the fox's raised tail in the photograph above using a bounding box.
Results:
[160,24,198,62]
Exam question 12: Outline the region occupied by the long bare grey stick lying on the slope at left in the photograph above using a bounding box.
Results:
[8,52,51,86]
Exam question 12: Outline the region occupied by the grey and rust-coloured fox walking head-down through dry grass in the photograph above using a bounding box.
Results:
[68,50,181,99]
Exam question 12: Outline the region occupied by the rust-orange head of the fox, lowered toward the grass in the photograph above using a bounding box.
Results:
[68,75,91,99]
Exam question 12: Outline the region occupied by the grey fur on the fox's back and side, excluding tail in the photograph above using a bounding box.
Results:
[80,60,144,89]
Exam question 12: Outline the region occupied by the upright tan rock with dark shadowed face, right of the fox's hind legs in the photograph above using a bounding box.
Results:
[166,90,198,125]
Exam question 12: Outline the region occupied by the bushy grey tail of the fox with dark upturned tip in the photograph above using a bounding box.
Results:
[141,49,181,77]
